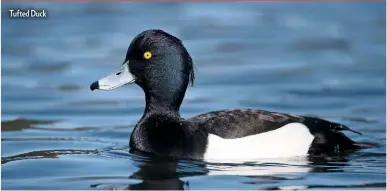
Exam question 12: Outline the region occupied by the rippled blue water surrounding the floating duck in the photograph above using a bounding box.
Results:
[1,2,386,190]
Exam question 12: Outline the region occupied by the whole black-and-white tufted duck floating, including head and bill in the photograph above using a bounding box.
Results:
[90,30,370,160]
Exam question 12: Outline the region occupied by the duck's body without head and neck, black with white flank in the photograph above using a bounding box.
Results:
[130,109,361,160]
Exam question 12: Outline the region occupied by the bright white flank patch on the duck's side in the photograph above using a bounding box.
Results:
[204,123,314,162]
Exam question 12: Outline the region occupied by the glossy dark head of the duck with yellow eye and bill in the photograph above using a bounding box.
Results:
[90,30,194,111]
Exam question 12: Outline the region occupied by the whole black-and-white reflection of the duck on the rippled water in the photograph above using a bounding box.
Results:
[93,150,354,190]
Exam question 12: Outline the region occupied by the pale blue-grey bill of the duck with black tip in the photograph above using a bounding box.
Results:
[90,64,135,91]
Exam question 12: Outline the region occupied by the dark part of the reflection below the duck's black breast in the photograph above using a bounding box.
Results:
[92,151,208,190]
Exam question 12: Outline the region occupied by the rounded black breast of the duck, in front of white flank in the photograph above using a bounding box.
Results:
[130,115,207,159]
